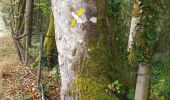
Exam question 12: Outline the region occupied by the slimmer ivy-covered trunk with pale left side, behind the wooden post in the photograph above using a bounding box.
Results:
[128,0,158,100]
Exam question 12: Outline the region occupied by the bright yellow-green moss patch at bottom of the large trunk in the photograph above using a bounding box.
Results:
[75,77,118,100]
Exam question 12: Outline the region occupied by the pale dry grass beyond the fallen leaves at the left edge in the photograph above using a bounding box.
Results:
[0,34,17,99]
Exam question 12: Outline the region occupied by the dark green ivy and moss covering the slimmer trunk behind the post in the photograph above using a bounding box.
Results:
[128,0,158,67]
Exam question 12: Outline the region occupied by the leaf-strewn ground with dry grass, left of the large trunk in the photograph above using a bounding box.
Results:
[0,35,59,100]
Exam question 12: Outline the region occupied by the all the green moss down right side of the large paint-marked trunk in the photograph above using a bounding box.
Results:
[73,1,126,100]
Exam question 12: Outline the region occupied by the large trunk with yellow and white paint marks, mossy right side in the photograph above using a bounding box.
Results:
[52,0,127,100]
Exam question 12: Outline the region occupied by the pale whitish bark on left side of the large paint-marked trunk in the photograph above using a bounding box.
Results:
[52,0,95,100]
